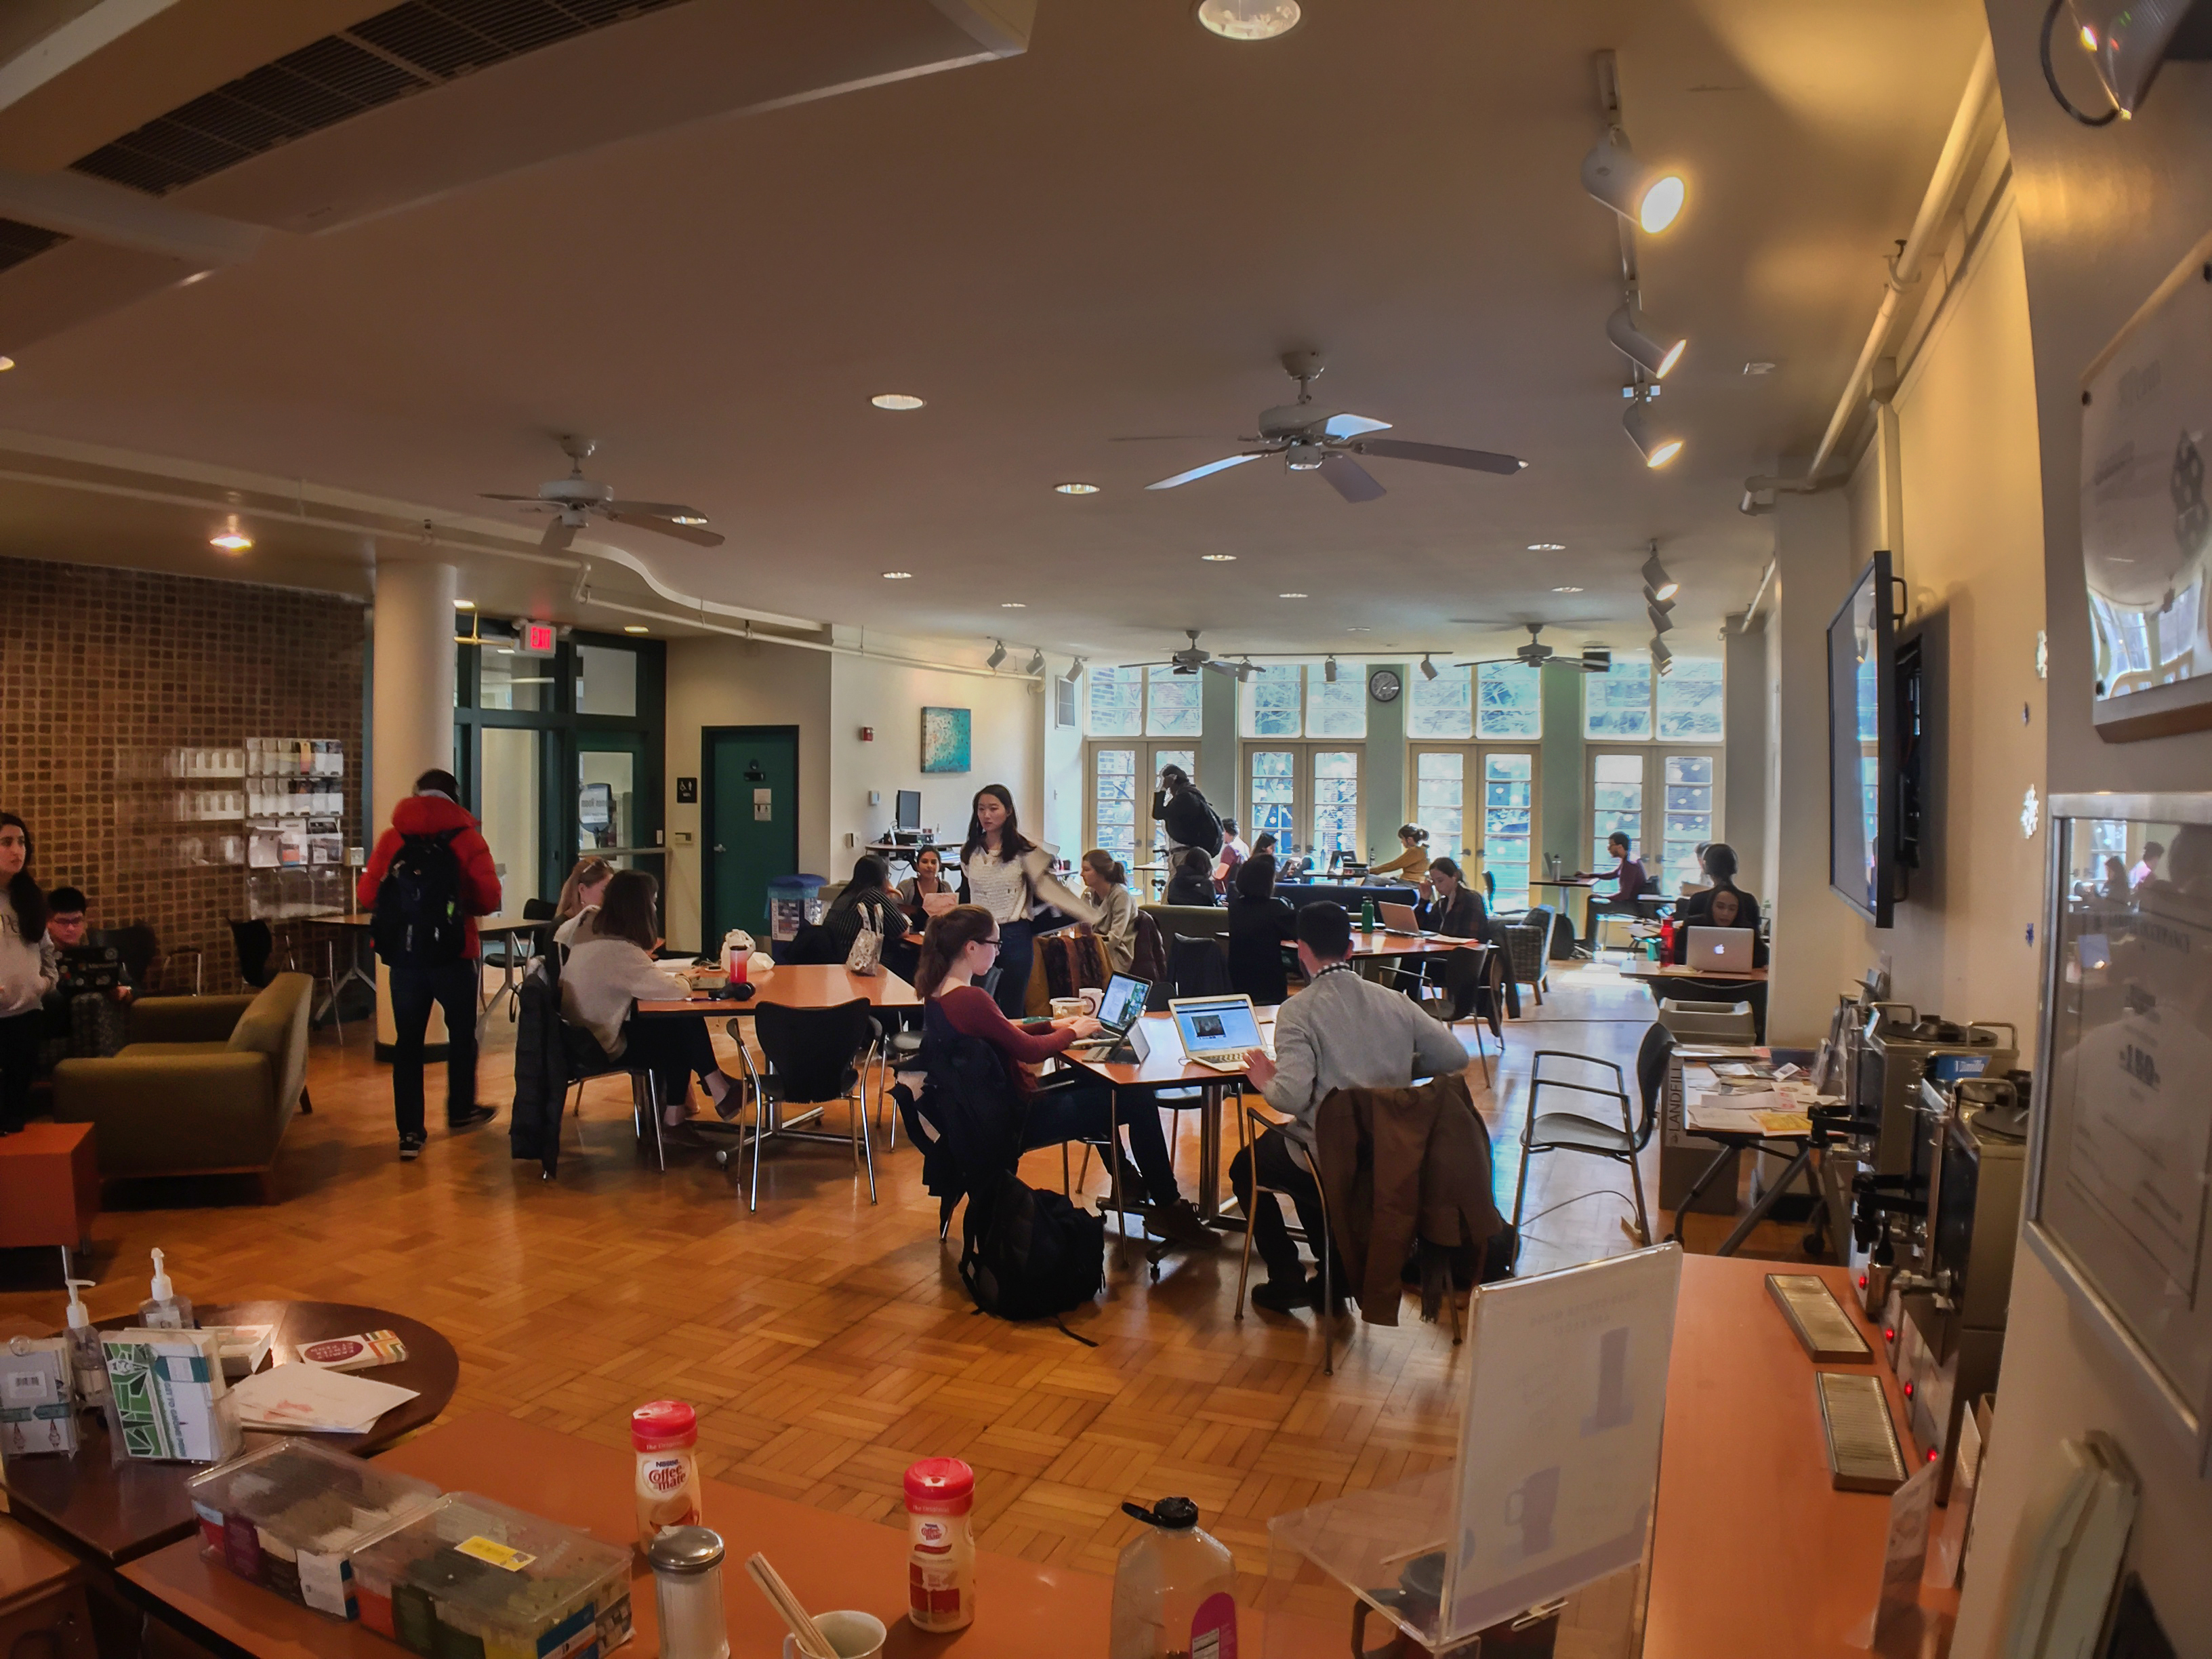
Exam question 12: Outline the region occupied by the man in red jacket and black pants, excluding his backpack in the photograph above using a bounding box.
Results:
[356,770,500,1164]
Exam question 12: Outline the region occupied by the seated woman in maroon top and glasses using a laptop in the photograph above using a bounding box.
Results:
[914,911,1216,1248]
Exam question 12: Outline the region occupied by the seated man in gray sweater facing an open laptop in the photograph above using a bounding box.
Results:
[1230,903,1467,1314]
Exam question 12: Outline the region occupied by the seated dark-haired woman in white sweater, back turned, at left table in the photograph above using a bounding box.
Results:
[560,869,739,1124]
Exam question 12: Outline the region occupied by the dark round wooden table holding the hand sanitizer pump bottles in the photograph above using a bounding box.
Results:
[7,1303,460,1564]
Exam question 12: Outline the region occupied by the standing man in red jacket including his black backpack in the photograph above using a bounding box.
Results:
[354,768,500,1164]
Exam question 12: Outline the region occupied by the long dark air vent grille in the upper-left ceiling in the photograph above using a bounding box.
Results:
[71,0,684,200]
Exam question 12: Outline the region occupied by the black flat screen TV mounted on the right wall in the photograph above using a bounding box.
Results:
[1827,553,1900,927]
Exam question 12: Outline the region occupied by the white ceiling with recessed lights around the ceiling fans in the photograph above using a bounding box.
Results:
[0,0,1982,659]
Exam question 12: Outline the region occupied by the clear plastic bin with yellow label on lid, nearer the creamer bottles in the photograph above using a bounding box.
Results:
[354,1493,630,1659]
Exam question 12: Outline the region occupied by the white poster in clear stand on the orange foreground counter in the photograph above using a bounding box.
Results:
[1440,1246,1681,1641]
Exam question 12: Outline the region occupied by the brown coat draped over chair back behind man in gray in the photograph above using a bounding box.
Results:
[1316,1075,1507,1325]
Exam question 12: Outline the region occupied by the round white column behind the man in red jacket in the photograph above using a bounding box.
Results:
[369,560,460,1044]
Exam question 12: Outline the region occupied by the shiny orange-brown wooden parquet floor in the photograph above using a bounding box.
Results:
[0,969,1792,1573]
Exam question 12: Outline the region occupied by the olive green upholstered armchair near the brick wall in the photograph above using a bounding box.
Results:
[53,973,314,1204]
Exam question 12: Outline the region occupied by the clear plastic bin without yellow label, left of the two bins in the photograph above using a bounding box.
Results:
[186,1440,438,1619]
